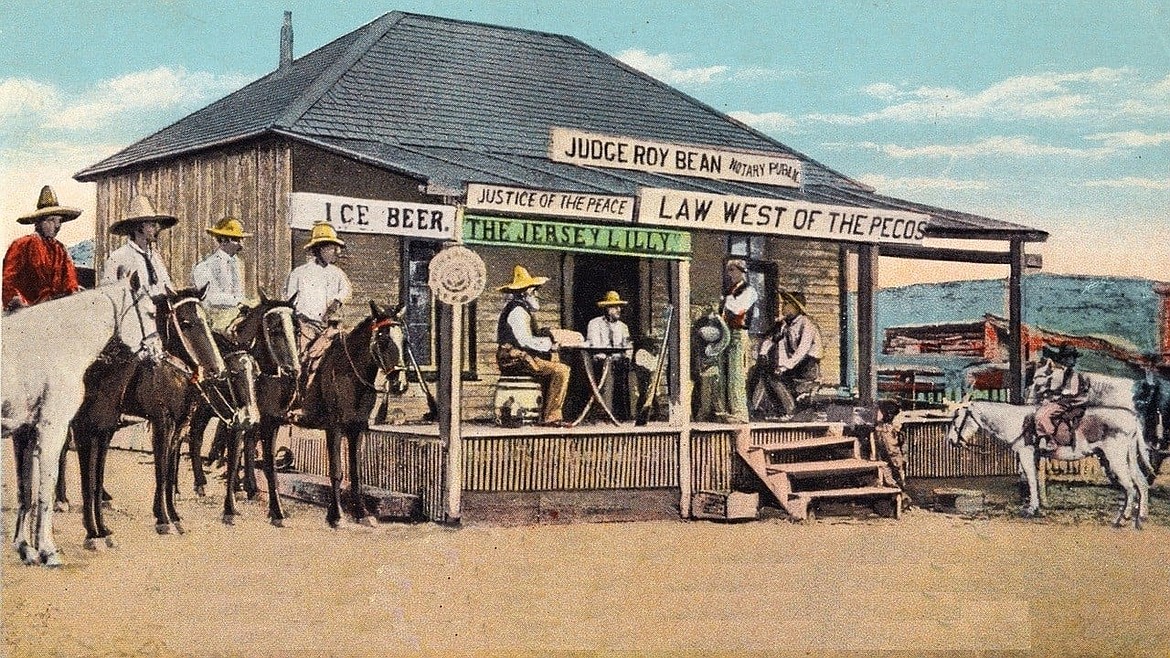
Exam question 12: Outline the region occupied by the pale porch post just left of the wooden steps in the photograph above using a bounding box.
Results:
[673,260,693,519]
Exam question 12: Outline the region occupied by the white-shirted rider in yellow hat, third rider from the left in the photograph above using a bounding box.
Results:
[191,217,252,331]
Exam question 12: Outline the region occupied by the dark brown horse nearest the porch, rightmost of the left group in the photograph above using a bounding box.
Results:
[297,301,408,528]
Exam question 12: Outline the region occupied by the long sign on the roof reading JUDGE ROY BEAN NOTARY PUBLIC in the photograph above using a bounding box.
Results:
[549,128,801,187]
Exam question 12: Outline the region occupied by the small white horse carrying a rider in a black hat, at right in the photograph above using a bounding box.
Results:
[947,393,1154,528]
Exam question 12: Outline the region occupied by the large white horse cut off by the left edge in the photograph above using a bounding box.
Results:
[0,274,161,567]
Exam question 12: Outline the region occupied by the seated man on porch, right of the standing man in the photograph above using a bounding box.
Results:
[749,290,824,420]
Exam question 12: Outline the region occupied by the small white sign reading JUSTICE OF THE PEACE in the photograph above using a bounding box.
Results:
[467,183,634,221]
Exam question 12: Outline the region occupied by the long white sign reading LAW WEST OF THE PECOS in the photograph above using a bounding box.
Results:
[638,187,930,245]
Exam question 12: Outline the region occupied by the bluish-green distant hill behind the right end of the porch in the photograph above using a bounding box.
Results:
[875,273,1159,376]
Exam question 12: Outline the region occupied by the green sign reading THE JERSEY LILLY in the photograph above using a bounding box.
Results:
[463,214,690,259]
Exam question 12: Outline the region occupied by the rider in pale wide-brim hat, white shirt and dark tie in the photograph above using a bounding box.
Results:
[99,194,179,295]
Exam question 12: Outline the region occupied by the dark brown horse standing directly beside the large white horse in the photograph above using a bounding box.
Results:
[73,287,257,540]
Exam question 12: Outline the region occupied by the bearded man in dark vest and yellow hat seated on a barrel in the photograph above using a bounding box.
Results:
[496,265,569,426]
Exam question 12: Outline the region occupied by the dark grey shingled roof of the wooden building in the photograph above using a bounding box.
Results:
[75,12,1047,240]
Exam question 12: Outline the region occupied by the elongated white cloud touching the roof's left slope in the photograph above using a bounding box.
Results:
[46,67,247,130]
